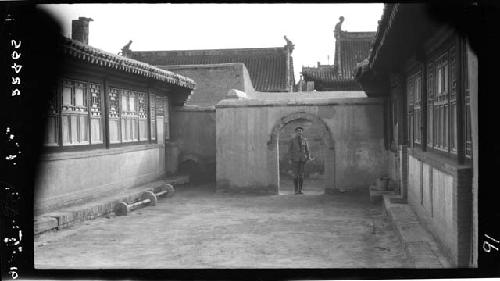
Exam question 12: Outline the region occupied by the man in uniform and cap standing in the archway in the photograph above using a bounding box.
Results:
[288,127,311,194]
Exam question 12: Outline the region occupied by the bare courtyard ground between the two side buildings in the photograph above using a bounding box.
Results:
[35,179,413,269]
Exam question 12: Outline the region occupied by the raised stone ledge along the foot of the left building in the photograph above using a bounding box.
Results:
[34,176,189,235]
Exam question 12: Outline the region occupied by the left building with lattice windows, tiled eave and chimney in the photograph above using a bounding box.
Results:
[35,18,195,214]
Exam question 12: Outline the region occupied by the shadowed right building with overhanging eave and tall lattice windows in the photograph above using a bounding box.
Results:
[356,4,478,267]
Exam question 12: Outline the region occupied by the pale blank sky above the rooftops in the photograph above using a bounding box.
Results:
[39,3,383,81]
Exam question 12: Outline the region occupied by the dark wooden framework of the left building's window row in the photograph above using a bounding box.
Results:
[44,77,157,152]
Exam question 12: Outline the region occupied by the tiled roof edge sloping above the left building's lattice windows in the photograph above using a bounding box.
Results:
[63,37,195,89]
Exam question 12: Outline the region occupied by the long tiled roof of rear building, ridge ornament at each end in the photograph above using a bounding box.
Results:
[131,47,295,92]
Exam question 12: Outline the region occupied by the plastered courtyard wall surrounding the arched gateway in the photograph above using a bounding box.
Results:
[216,97,388,194]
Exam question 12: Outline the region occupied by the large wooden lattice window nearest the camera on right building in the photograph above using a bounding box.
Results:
[423,37,471,164]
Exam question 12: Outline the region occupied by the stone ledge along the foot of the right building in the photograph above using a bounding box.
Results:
[383,194,450,268]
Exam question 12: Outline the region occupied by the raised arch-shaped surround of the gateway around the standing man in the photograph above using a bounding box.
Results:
[267,112,335,193]
